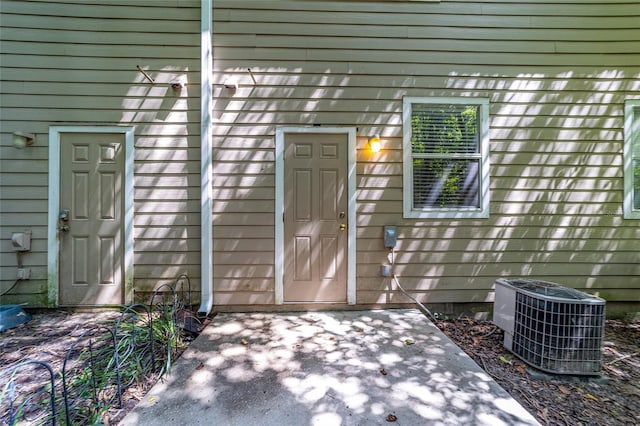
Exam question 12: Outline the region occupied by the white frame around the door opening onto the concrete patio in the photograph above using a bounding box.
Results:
[274,126,357,305]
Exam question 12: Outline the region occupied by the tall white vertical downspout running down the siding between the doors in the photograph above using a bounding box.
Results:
[198,0,213,315]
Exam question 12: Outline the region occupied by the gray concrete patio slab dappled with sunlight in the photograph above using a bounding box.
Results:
[120,309,538,426]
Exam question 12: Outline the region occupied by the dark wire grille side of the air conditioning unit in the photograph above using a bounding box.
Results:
[512,292,605,374]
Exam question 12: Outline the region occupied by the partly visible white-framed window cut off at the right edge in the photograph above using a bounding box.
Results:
[623,99,640,219]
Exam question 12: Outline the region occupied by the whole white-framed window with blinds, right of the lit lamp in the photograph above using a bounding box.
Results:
[403,97,489,218]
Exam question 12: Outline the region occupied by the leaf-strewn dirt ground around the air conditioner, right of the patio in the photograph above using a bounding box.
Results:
[438,319,640,426]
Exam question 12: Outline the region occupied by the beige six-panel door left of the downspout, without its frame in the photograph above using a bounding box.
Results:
[58,133,126,306]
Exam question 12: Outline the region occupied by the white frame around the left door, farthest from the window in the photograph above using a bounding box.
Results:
[47,126,135,307]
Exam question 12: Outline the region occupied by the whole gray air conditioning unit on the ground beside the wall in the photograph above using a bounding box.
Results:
[493,279,606,375]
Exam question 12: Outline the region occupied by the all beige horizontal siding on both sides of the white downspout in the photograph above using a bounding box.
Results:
[0,0,640,304]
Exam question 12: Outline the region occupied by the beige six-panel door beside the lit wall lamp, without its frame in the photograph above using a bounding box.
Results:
[283,133,348,303]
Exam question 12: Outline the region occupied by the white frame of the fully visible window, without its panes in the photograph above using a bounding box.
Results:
[402,97,489,219]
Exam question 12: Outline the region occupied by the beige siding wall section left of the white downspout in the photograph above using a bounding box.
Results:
[0,0,200,307]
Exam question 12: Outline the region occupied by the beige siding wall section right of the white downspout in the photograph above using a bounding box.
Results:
[214,0,640,305]
